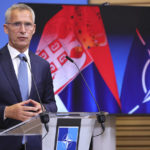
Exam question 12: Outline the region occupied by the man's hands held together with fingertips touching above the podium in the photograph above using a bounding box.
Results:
[5,99,42,121]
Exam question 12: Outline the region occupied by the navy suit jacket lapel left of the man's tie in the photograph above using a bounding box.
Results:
[0,46,21,101]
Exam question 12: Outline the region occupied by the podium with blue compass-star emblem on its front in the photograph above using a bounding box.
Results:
[0,112,106,150]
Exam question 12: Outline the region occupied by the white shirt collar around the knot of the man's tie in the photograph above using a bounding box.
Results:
[7,43,29,60]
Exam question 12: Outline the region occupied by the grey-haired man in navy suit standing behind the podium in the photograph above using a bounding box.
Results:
[0,4,57,150]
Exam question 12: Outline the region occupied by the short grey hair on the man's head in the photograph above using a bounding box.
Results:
[5,4,35,23]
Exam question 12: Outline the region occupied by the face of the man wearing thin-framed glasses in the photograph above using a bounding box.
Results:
[4,9,36,52]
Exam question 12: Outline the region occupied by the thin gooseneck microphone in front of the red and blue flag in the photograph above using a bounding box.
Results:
[66,56,106,133]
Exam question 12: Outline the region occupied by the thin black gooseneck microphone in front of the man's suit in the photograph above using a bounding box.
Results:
[23,56,49,132]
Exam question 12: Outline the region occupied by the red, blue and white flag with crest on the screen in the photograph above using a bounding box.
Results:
[36,5,121,113]
